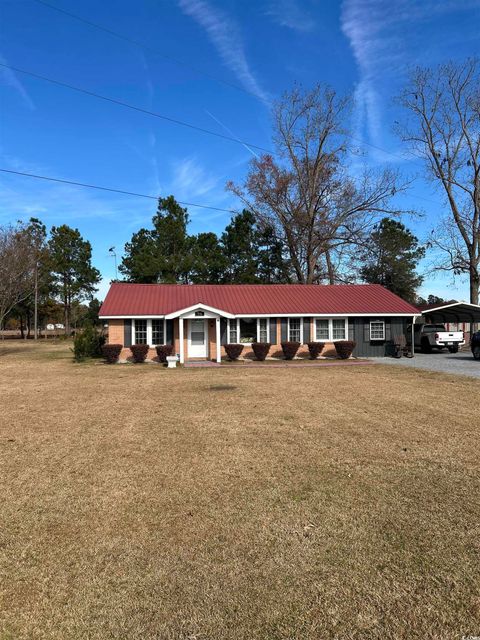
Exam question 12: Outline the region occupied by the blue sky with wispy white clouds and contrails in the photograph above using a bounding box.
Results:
[0,0,480,299]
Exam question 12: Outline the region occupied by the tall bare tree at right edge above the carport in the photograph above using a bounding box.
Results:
[399,59,480,304]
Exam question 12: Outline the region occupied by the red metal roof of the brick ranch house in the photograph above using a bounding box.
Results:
[100,282,419,318]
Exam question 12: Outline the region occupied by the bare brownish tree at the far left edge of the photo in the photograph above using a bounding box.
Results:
[0,224,36,336]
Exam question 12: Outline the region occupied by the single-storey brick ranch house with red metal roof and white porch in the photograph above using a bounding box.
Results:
[99,282,420,362]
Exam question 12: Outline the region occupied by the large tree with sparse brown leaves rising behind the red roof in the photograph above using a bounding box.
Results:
[227,85,406,284]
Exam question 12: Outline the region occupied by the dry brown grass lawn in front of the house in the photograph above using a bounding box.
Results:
[0,343,480,640]
